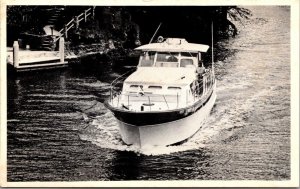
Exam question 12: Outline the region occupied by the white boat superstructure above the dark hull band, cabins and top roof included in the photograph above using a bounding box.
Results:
[110,38,212,111]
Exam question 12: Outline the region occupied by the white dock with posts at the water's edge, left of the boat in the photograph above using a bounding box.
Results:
[7,38,77,72]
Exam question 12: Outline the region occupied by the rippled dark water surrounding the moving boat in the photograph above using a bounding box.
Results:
[7,6,290,181]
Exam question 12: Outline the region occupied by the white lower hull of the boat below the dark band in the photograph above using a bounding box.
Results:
[118,87,216,148]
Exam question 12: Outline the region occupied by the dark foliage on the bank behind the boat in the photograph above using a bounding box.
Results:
[7,6,251,48]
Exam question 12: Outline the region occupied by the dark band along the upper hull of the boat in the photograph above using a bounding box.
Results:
[105,85,213,126]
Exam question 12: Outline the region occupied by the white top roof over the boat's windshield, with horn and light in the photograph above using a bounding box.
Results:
[135,38,209,52]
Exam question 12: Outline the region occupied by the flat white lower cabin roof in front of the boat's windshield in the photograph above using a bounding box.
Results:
[125,67,195,86]
